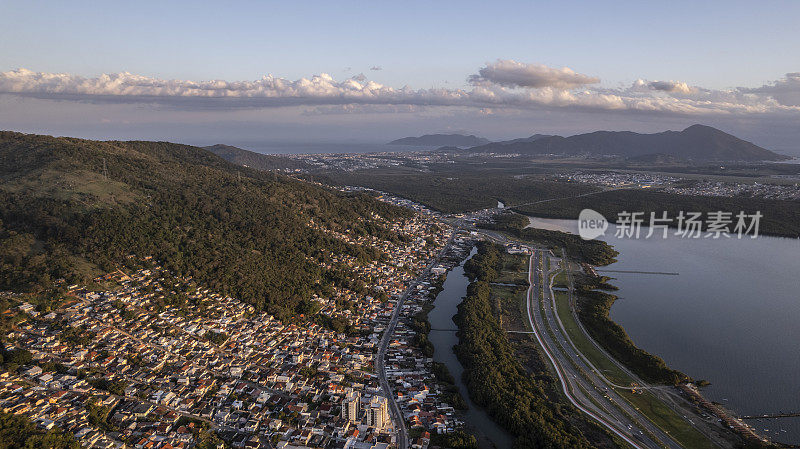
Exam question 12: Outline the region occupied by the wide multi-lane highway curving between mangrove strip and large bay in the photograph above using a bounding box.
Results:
[527,250,681,449]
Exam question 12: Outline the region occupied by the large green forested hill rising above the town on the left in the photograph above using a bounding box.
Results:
[0,132,407,317]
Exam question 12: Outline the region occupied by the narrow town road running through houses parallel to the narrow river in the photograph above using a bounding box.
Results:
[375,232,456,449]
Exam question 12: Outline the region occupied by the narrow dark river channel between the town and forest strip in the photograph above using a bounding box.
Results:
[428,248,513,449]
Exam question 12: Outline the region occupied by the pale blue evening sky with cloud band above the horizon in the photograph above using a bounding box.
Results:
[0,0,800,154]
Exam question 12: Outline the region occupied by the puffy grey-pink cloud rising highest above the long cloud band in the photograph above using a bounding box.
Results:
[469,59,600,89]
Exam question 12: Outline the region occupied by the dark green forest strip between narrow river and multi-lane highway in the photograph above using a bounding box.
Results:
[455,242,608,449]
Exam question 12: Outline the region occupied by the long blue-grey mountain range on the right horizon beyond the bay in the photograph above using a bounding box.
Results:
[471,125,788,161]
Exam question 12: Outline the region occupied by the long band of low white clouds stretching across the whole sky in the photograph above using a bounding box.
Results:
[0,65,800,116]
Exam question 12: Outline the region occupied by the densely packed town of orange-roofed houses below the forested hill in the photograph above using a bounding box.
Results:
[0,196,482,449]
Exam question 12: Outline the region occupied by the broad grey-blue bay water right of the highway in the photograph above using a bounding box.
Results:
[531,218,800,444]
